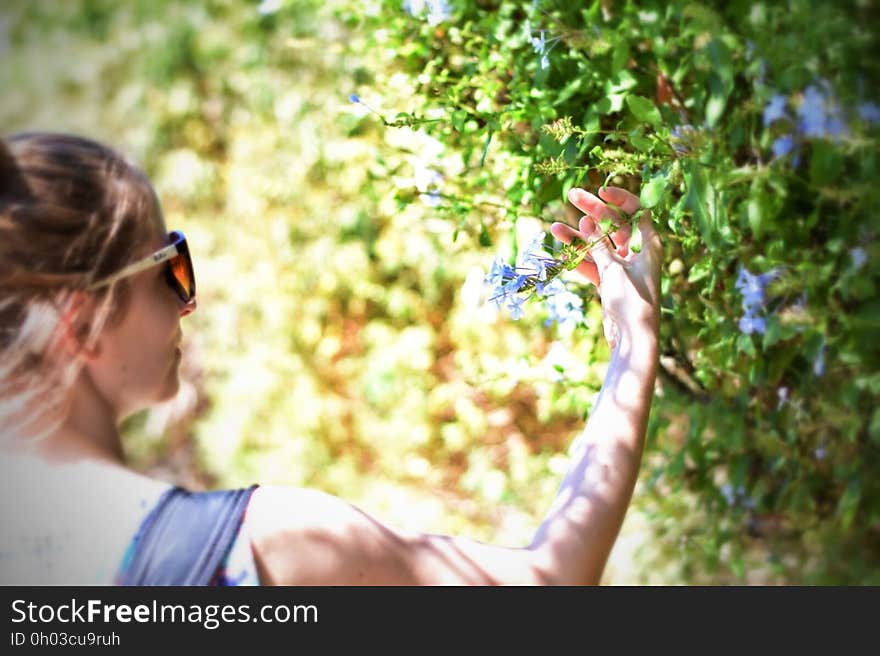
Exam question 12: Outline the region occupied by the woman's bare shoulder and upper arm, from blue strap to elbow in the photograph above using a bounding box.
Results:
[246,486,541,585]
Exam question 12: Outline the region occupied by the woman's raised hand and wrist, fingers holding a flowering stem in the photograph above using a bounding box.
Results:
[550,187,662,349]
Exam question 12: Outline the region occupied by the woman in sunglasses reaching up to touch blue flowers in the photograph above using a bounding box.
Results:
[0,133,660,585]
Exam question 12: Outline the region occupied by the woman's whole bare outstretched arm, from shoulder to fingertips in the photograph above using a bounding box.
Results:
[246,188,660,585]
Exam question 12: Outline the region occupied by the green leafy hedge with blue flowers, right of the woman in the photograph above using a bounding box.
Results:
[343,0,880,584]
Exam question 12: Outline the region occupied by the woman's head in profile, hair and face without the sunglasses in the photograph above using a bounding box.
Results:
[0,133,194,437]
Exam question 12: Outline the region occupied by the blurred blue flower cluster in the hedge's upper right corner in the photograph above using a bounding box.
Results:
[763,80,880,165]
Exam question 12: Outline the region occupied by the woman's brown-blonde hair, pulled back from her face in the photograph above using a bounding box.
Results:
[0,133,159,440]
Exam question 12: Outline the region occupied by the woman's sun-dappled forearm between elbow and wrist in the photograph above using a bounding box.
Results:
[530,326,658,584]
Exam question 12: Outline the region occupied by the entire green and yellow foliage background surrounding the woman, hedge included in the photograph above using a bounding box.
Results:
[0,0,880,583]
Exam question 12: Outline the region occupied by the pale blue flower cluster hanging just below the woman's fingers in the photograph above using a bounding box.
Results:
[484,232,588,332]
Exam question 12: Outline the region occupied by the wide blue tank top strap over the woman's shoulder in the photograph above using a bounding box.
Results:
[116,485,257,585]
